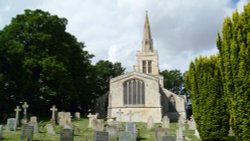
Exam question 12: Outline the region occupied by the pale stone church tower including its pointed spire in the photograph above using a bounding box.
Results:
[135,13,159,75]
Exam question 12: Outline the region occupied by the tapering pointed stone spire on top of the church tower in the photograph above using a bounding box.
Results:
[142,11,153,51]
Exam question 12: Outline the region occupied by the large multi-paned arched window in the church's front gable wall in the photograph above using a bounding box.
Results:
[123,79,145,105]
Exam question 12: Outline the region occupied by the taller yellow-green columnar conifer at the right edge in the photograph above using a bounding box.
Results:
[217,2,250,141]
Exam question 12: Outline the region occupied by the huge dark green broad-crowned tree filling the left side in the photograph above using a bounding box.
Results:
[0,10,92,117]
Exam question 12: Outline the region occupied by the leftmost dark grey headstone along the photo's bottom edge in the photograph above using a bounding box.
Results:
[21,124,33,141]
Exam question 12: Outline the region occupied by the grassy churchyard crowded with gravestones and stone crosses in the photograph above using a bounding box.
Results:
[0,103,199,141]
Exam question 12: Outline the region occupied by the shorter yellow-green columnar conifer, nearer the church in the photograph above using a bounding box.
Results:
[185,56,229,141]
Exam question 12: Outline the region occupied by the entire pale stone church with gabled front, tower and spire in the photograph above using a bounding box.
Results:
[107,14,186,123]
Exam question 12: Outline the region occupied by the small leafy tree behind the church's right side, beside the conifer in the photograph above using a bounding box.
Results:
[160,70,184,94]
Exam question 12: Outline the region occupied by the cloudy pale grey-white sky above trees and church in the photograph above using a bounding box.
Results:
[0,0,248,72]
